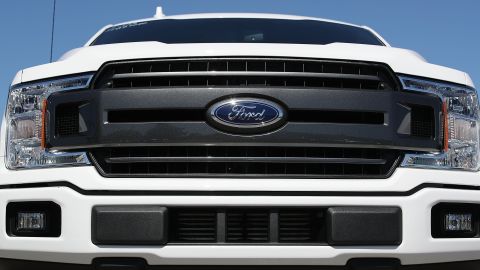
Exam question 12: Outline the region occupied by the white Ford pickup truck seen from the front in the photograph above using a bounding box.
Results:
[0,10,480,270]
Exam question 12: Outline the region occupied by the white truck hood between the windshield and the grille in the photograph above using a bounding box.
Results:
[13,42,473,87]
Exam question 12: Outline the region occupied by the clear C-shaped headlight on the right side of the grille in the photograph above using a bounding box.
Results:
[400,77,480,171]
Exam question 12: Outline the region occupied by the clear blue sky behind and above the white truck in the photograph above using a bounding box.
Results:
[0,0,480,110]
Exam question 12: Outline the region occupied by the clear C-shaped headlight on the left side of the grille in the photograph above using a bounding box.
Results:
[6,75,92,169]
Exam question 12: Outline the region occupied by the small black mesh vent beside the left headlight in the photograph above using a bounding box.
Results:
[55,104,80,136]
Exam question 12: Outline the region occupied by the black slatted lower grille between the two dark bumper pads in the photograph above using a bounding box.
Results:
[169,208,326,244]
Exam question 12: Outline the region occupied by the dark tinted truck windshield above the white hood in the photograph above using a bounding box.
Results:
[91,18,384,45]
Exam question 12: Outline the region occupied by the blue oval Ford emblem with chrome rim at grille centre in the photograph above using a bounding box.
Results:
[207,98,285,133]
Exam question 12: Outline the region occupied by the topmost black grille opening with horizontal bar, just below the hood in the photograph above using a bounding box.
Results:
[94,58,396,90]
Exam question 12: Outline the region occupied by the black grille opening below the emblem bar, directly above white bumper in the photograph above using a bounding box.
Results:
[90,146,401,178]
